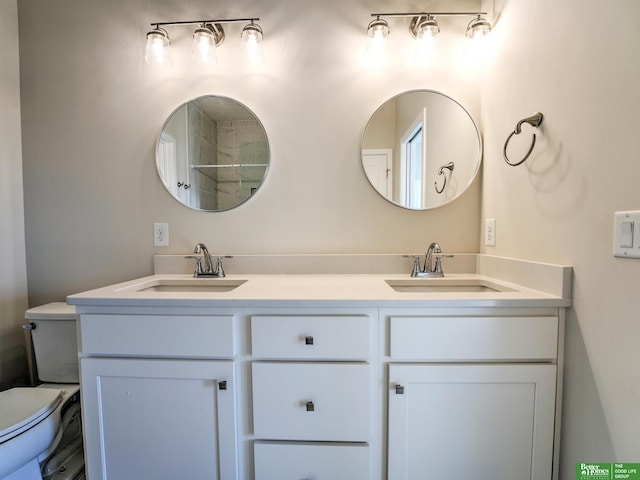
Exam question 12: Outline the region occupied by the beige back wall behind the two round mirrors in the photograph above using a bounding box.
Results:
[19,0,480,304]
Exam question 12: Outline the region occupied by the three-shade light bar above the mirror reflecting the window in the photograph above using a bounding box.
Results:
[367,12,491,40]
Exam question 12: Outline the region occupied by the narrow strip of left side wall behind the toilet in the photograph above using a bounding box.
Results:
[0,0,27,390]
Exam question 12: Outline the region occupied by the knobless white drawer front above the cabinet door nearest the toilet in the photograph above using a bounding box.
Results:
[80,314,235,358]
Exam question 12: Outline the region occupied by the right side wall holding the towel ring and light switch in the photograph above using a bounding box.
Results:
[482,0,640,472]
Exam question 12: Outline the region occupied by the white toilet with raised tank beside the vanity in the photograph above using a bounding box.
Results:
[0,303,85,480]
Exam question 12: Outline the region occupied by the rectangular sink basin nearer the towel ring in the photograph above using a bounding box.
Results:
[386,278,515,293]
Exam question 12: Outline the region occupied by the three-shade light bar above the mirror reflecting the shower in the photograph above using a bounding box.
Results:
[144,18,262,65]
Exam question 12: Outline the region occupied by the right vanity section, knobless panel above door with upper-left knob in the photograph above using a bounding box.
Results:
[386,310,560,480]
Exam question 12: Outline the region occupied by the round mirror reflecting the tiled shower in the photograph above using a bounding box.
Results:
[156,96,269,212]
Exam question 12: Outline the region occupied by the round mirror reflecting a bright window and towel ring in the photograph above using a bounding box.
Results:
[362,90,482,210]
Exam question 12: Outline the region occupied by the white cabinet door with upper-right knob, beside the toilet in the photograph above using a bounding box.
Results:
[80,358,238,480]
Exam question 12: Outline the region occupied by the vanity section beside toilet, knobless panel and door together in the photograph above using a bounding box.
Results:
[79,312,240,480]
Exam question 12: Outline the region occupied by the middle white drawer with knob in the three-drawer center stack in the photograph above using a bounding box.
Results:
[253,362,370,442]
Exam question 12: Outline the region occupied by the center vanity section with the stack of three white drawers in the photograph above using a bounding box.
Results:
[249,309,377,480]
